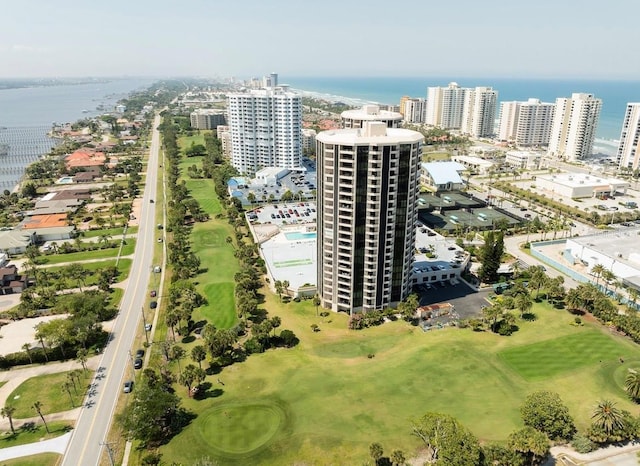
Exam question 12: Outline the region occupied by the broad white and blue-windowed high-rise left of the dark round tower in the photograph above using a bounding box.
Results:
[227,82,302,175]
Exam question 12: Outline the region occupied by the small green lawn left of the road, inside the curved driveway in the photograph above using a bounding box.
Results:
[6,371,93,419]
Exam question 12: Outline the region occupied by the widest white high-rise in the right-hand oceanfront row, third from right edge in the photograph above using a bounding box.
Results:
[498,99,555,147]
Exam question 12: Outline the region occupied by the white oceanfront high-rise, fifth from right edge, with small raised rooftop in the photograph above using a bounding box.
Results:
[426,82,467,129]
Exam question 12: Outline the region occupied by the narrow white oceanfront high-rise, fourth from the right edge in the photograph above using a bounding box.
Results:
[461,87,498,138]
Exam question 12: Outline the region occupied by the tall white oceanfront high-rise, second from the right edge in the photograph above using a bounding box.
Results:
[548,93,602,161]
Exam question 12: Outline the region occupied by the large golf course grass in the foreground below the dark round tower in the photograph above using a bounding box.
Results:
[161,293,640,465]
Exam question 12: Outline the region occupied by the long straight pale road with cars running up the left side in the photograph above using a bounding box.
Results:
[62,117,160,466]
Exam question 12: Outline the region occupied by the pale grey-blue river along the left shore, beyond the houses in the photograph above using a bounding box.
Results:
[0,78,156,190]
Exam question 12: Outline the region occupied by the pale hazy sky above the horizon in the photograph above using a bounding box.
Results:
[0,0,640,80]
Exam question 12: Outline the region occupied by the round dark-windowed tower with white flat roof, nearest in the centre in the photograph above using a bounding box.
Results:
[316,121,424,314]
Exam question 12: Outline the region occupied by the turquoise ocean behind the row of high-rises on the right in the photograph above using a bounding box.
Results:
[281,77,640,153]
